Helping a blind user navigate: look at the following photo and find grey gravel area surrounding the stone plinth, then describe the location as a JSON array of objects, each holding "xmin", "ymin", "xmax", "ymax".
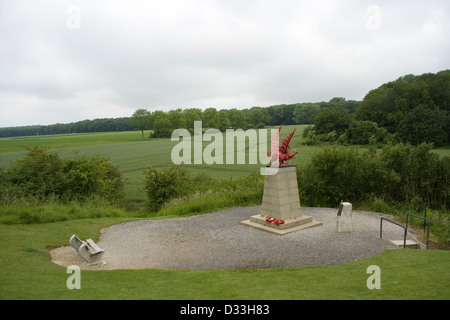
[{"xmin": 50, "ymin": 206, "xmax": 403, "ymax": 270}]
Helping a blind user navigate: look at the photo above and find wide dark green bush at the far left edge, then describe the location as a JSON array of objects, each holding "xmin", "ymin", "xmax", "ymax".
[{"xmin": 0, "ymin": 146, "xmax": 124, "ymax": 201}]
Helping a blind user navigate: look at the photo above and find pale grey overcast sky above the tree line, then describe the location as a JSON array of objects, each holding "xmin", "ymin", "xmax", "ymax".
[{"xmin": 0, "ymin": 0, "xmax": 450, "ymax": 127}]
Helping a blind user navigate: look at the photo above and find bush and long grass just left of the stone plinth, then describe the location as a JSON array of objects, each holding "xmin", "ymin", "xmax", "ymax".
[{"xmin": 145, "ymin": 165, "xmax": 264, "ymax": 215}]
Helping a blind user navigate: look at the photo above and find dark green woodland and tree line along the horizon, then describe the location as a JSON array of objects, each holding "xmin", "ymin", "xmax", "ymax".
[{"xmin": 0, "ymin": 70, "xmax": 450, "ymax": 146}]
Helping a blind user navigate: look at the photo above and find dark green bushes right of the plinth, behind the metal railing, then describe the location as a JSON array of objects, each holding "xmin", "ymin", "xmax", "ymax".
[{"xmin": 297, "ymin": 144, "xmax": 450, "ymax": 210}]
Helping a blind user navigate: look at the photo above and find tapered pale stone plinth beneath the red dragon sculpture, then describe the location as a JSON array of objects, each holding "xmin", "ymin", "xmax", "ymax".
[{"xmin": 241, "ymin": 166, "xmax": 322, "ymax": 234}]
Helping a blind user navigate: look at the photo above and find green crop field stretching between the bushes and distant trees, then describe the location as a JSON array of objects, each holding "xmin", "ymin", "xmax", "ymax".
[{"xmin": 0, "ymin": 125, "xmax": 320, "ymax": 200}]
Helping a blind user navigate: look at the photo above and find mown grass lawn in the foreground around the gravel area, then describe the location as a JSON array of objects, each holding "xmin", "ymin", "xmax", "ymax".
[{"xmin": 0, "ymin": 218, "xmax": 450, "ymax": 300}]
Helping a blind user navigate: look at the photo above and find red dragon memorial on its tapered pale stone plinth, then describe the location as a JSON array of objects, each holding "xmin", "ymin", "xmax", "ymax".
[{"xmin": 241, "ymin": 125, "xmax": 322, "ymax": 235}]
